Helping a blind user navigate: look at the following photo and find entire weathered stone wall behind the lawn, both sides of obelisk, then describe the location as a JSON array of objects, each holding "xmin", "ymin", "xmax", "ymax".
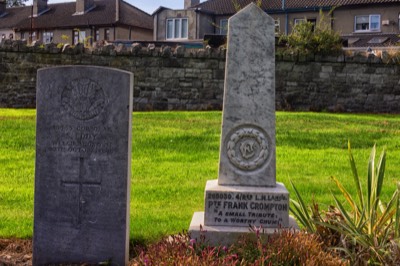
[{"xmin": 0, "ymin": 42, "xmax": 400, "ymax": 113}]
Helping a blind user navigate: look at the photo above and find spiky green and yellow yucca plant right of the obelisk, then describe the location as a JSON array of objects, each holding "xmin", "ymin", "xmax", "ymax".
[{"xmin": 292, "ymin": 142, "xmax": 400, "ymax": 264}]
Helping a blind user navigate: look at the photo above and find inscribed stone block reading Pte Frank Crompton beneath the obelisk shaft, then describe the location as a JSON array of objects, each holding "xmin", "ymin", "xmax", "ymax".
[{"xmin": 204, "ymin": 180, "xmax": 289, "ymax": 228}]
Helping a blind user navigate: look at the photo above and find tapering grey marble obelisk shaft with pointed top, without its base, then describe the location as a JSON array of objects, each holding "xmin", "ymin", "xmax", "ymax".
[{"xmin": 218, "ymin": 4, "xmax": 276, "ymax": 186}]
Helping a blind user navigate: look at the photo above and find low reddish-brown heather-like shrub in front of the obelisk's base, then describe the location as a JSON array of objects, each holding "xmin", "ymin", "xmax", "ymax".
[{"xmin": 131, "ymin": 231, "xmax": 348, "ymax": 266}]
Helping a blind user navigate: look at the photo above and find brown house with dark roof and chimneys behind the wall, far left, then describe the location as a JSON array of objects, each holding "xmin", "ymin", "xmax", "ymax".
[{"xmin": 0, "ymin": 0, "xmax": 153, "ymax": 44}]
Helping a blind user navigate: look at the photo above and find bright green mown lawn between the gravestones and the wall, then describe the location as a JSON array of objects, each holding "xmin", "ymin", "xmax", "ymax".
[{"xmin": 0, "ymin": 109, "xmax": 400, "ymax": 243}]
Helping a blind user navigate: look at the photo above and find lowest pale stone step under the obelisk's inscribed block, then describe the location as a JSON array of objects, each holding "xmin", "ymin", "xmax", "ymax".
[{"xmin": 189, "ymin": 212, "xmax": 300, "ymax": 246}]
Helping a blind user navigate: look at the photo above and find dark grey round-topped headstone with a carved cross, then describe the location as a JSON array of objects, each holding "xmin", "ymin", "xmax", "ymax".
[{"xmin": 33, "ymin": 66, "xmax": 133, "ymax": 265}]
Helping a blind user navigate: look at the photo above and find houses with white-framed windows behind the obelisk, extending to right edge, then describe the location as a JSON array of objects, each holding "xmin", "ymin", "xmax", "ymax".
[{"xmin": 153, "ymin": 0, "xmax": 400, "ymax": 46}]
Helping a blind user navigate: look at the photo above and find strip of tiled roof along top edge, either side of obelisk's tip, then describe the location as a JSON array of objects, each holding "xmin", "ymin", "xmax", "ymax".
[{"xmin": 192, "ymin": 0, "xmax": 400, "ymax": 15}]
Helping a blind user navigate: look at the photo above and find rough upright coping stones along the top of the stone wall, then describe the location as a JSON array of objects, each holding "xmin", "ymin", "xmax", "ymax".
[{"xmin": 0, "ymin": 40, "xmax": 400, "ymax": 64}]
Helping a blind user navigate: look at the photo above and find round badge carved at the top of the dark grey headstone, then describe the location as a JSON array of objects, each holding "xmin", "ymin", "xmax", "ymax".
[{"xmin": 61, "ymin": 78, "xmax": 105, "ymax": 120}]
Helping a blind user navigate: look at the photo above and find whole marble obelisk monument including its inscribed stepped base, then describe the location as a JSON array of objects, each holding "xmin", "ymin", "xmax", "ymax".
[{"xmin": 189, "ymin": 3, "xmax": 296, "ymax": 244}]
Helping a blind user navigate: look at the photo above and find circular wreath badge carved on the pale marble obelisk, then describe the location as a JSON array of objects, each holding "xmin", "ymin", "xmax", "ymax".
[{"xmin": 226, "ymin": 125, "xmax": 271, "ymax": 171}]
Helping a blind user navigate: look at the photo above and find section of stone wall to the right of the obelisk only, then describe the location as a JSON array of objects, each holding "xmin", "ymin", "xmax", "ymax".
[{"xmin": 276, "ymin": 54, "xmax": 400, "ymax": 113}]
